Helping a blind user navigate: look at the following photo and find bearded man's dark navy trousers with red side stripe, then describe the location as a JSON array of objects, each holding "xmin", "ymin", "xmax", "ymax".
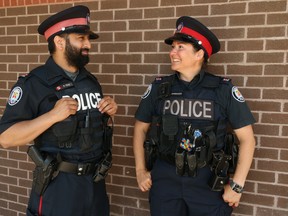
[{"xmin": 27, "ymin": 172, "xmax": 110, "ymax": 216}]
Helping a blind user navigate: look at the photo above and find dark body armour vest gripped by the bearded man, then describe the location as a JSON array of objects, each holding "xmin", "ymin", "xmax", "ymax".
[{"xmin": 30, "ymin": 66, "xmax": 103, "ymax": 160}]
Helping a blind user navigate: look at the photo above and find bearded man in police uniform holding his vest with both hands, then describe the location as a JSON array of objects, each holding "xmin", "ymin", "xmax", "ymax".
[{"xmin": 0, "ymin": 6, "xmax": 117, "ymax": 216}]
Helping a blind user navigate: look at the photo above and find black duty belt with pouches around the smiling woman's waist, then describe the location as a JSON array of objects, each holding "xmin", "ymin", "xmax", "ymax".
[{"xmin": 144, "ymin": 137, "xmax": 238, "ymax": 191}]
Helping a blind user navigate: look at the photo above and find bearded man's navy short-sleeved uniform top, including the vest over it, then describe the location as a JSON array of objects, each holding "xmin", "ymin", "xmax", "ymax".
[{"xmin": 0, "ymin": 57, "xmax": 103, "ymax": 161}]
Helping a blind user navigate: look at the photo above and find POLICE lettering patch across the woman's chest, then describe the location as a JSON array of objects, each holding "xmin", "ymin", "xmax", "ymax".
[{"xmin": 163, "ymin": 99, "xmax": 214, "ymax": 120}]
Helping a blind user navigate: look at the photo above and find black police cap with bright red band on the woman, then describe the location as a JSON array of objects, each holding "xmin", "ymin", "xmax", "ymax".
[{"xmin": 165, "ymin": 16, "xmax": 220, "ymax": 58}]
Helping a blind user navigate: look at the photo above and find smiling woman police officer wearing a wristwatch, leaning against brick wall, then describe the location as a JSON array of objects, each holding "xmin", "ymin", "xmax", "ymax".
[{"xmin": 133, "ymin": 16, "xmax": 255, "ymax": 216}]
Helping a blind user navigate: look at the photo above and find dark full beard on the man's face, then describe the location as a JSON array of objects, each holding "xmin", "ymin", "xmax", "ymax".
[{"xmin": 65, "ymin": 39, "xmax": 89, "ymax": 68}]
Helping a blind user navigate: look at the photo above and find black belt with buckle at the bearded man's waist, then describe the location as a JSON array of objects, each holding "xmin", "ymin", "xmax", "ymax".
[{"xmin": 57, "ymin": 161, "xmax": 98, "ymax": 176}]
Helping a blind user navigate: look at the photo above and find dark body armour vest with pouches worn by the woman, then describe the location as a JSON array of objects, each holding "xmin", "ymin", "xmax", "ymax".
[{"xmin": 150, "ymin": 72, "xmax": 227, "ymax": 167}]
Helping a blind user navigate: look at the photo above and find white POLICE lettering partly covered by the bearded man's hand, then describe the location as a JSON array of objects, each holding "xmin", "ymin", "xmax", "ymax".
[{"xmin": 63, "ymin": 93, "xmax": 102, "ymax": 111}]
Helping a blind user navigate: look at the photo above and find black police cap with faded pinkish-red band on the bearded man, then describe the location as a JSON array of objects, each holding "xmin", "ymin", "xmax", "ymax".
[{"xmin": 38, "ymin": 5, "xmax": 99, "ymax": 41}]
